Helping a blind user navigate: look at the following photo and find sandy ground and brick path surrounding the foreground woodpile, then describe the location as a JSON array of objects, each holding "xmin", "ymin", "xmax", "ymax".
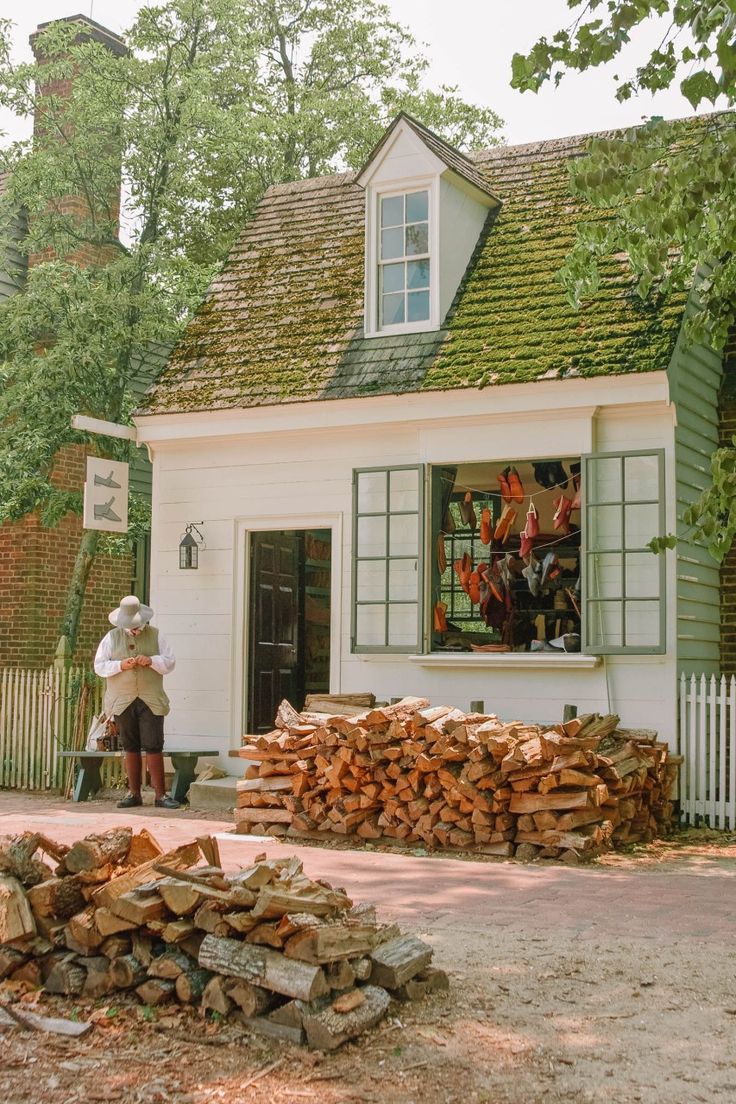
[{"xmin": 0, "ymin": 794, "xmax": 736, "ymax": 1104}]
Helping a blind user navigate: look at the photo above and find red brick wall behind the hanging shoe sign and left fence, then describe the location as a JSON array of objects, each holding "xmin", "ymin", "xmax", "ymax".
[{"xmin": 0, "ymin": 446, "xmax": 132, "ymax": 667}]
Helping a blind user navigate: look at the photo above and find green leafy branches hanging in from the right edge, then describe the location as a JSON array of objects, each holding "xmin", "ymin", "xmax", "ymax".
[{"xmin": 512, "ymin": 0, "xmax": 736, "ymax": 562}]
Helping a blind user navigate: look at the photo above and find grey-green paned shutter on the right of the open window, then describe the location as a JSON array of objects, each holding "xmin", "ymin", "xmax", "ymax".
[{"xmin": 582, "ymin": 449, "xmax": 665, "ymax": 656}]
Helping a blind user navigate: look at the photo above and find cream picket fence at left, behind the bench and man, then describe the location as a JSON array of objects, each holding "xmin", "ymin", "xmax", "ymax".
[{"xmin": 0, "ymin": 667, "xmax": 106, "ymax": 789}]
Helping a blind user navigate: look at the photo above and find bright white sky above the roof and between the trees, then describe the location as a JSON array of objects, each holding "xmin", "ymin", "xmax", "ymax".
[{"xmin": 0, "ymin": 0, "xmax": 693, "ymax": 144}]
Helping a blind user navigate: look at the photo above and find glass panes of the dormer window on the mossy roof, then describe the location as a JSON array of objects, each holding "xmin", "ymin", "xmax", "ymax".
[{"xmin": 378, "ymin": 189, "xmax": 430, "ymax": 329}]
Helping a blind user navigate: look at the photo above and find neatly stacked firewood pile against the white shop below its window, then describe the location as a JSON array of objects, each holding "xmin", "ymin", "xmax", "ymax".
[{"xmin": 235, "ymin": 698, "xmax": 676, "ymax": 861}]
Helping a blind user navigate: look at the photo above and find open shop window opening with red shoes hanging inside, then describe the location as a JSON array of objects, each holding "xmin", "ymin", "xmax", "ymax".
[{"xmin": 431, "ymin": 457, "xmax": 583, "ymax": 654}]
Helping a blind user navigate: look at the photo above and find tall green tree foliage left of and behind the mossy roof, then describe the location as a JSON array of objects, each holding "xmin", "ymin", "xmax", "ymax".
[{"xmin": 0, "ymin": 0, "xmax": 500, "ymax": 647}]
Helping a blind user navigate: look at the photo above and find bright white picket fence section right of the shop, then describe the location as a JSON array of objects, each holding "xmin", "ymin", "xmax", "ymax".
[{"xmin": 678, "ymin": 675, "xmax": 736, "ymax": 831}]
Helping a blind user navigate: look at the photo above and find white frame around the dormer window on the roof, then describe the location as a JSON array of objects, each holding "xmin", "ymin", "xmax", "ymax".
[{"xmin": 364, "ymin": 177, "xmax": 440, "ymax": 338}]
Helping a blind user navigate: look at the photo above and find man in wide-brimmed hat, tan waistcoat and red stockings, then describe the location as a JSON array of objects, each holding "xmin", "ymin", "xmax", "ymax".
[{"xmin": 95, "ymin": 594, "xmax": 179, "ymax": 809}]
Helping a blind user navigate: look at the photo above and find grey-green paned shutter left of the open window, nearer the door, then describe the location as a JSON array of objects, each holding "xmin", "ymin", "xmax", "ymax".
[{"xmin": 351, "ymin": 465, "xmax": 425, "ymax": 652}]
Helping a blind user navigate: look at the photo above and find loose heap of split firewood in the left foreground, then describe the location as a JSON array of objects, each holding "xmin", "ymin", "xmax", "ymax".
[{"xmin": 0, "ymin": 828, "xmax": 447, "ymax": 1050}]
